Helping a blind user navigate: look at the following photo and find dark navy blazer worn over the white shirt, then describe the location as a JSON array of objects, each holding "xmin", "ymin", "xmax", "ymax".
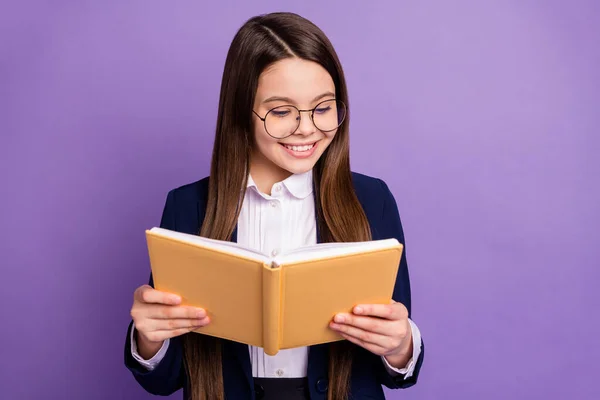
[{"xmin": 125, "ymin": 173, "xmax": 425, "ymax": 400}]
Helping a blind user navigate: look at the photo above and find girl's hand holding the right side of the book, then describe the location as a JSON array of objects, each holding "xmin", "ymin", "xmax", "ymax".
[{"xmin": 329, "ymin": 300, "xmax": 413, "ymax": 368}]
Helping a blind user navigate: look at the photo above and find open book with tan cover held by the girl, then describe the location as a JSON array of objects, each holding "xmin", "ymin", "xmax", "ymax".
[{"xmin": 146, "ymin": 228, "xmax": 403, "ymax": 355}]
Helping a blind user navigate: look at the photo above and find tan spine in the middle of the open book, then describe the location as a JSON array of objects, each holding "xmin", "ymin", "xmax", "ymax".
[{"xmin": 262, "ymin": 265, "xmax": 281, "ymax": 356}]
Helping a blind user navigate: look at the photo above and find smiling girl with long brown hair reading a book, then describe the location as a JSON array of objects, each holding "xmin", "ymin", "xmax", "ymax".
[{"xmin": 125, "ymin": 13, "xmax": 424, "ymax": 400}]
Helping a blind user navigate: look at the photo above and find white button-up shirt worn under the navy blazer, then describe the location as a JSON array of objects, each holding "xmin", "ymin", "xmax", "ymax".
[{"xmin": 130, "ymin": 171, "xmax": 421, "ymax": 379}]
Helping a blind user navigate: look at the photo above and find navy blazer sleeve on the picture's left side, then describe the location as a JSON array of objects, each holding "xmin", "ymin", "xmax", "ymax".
[{"xmin": 124, "ymin": 191, "xmax": 185, "ymax": 396}]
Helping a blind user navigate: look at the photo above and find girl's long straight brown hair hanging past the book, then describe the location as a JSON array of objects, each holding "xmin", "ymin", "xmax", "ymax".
[{"xmin": 184, "ymin": 13, "xmax": 371, "ymax": 400}]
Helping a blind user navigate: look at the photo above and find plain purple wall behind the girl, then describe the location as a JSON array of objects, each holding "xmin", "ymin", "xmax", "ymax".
[{"xmin": 0, "ymin": 0, "xmax": 600, "ymax": 400}]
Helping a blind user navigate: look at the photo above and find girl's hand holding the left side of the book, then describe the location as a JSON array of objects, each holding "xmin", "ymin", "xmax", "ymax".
[{"xmin": 131, "ymin": 285, "xmax": 210, "ymax": 359}]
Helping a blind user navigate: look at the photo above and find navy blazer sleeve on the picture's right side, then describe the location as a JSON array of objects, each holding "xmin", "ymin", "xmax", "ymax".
[{"xmin": 374, "ymin": 180, "xmax": 425, "ymax": 389}]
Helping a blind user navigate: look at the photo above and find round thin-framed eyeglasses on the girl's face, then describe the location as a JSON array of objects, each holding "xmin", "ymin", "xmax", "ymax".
[{"xmin": 252, "ymin": 99, "xmax": 346, "ymax": 139}]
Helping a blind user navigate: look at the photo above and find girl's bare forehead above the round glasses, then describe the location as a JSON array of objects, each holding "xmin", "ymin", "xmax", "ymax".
[{"xmin": 256, "ymin": 58, "xmax": 335, "ymax": 103}]
